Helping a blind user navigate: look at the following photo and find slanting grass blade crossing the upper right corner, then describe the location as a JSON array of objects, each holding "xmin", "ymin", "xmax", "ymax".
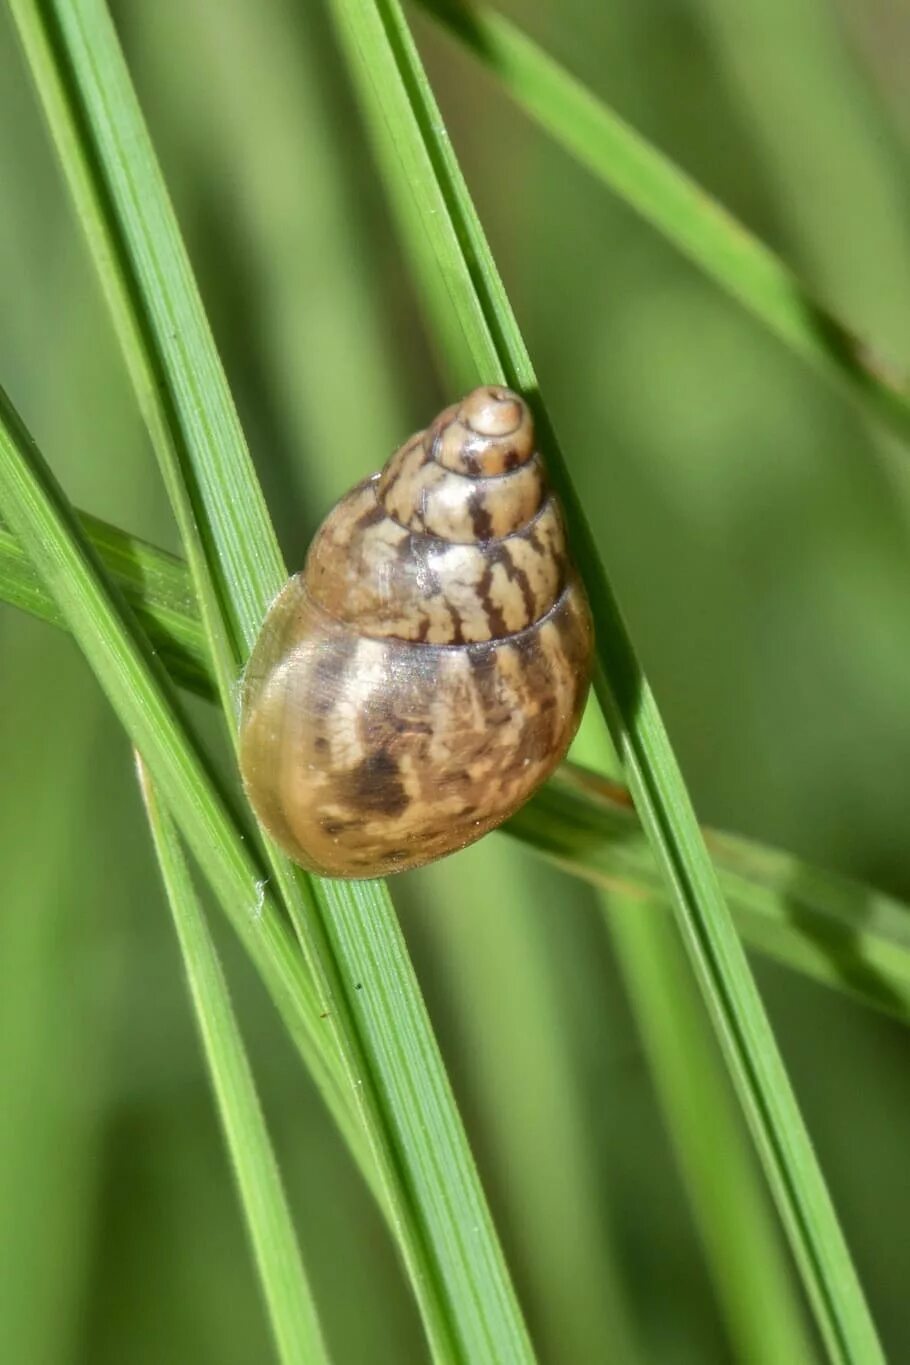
[{"xmin": 419, "ymin": 0, "xmax": 910, "ymax": 442}]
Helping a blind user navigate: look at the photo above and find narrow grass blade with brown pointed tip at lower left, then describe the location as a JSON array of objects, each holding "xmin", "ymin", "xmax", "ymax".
[{"xmin": 136, "ymin": 756, "xmax": 329, "ymax": 1365}]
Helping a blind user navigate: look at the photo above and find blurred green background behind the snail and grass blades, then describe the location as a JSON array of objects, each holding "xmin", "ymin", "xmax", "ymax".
[{"xmin": 0, "ymin": 0, "xmax": 910, "ymax": 1365}]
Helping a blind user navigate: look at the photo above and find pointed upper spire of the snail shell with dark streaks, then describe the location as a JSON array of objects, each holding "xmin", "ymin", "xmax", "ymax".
[{"xmin": 304, "ymin": 388, "xmax": 568, "ymax": 644}]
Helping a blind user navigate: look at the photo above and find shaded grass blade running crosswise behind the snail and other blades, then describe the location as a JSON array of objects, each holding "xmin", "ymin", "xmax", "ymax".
[{"xmin": 0, "ymin": 513, "xmax": 910, "ymax": 1022}]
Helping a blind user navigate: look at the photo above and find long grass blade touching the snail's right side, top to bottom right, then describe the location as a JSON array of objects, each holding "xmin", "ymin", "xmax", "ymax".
[{"xmin": 326, "ymin": 0, "xmax": 880, "ymax": 1362}]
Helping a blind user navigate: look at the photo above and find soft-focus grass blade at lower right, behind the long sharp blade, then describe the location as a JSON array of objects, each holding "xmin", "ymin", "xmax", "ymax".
[{"xmin": 572, "ymin": 713, "xmax": 814, "ymax": 1365}]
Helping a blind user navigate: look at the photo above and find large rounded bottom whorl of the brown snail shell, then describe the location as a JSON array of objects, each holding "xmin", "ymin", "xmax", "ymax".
[{"xmin": 241, "ymin": 576, "xmax": 591, "ymax": 876}]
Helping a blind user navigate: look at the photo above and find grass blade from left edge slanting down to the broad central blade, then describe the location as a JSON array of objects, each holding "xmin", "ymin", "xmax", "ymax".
[{"xmin": 0, "ymin": 390, "xmax": 372, "ymax": 1206}]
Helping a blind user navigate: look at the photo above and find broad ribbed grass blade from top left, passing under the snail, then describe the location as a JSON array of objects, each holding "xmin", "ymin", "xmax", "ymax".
[{"xmin": 14, "ymin": 0, "xmax": 529, "ymax": 1360}]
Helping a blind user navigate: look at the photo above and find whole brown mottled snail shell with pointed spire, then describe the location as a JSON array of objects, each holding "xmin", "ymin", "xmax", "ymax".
[{"xmin": 240, "ymin": 386, "xmax": 592, "ymax": 878}]
